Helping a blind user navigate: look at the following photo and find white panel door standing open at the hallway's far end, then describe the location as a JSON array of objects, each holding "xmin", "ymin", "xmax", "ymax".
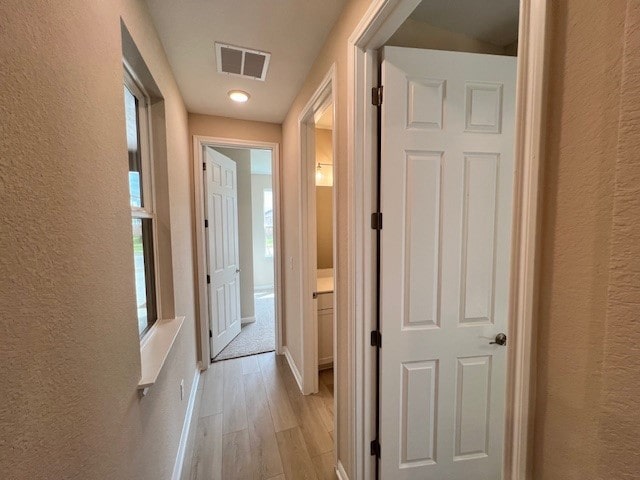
[{"xmin": 204, "ymin": 148, "xmax": 241, "ymax": 357}]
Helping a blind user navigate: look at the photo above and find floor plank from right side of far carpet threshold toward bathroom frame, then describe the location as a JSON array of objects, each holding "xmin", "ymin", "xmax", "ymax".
[{"xmin": 258, "ymin": 353, "xmax": 298, "ymax": 432}]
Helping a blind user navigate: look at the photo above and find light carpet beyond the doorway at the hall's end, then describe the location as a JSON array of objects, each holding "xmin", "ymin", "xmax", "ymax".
[{"xmin": 213, "ymin": 290, "xmax": 276, "ymax": 362}]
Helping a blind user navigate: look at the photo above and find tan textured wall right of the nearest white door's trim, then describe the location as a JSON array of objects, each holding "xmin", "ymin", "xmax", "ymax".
[{"xmin": 533, "ymin": 0, "xmax": 640, "ymax": 480}]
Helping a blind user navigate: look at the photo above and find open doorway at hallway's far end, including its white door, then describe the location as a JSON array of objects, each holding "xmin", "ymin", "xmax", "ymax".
[{"xmin": 194, "ymin": 137, "xmax": 281, "ymax": 362}]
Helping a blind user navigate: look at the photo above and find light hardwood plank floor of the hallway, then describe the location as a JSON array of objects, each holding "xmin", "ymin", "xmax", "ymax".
[{"xmin": 182, "ymin": 352, "xmax": 337, "ymax": 480}]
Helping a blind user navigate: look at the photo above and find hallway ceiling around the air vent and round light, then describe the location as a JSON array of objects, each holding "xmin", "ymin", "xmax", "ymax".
[{"xmin": 146, "ymin": 0, "xmax": 346, "ymax": 123}]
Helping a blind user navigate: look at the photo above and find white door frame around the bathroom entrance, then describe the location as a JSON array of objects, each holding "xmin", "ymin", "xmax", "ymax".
[{"xmin": 300, "ymin": 63, "xmax": 339, "ymax": 396}]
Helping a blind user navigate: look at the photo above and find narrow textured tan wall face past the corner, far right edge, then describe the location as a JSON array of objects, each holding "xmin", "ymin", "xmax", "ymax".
[{"xmin": 598, "ymin": 1, "xmax": 640, "ymax": 479}]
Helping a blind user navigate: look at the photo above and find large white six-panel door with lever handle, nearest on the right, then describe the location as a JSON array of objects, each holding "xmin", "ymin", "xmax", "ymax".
[{"xmin": 380, "ymin": 47, "xmax": 516, "ymax": 480}]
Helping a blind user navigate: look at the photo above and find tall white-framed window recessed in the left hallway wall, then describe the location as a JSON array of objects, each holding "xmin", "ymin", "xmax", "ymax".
[{"xmin": 124, "ymin": 68, "xmax": 158, "ymax": 337}]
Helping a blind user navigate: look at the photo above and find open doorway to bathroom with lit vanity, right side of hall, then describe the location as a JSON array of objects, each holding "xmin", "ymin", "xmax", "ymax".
[{"xmin": 299, "ymin": 66, "xmax": 339, "ymax": 396}]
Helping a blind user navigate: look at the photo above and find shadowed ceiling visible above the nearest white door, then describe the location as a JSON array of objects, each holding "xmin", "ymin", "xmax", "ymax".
[{"xmin": 411, "ymin": 0, "xmax": 520, "ymax": 47}]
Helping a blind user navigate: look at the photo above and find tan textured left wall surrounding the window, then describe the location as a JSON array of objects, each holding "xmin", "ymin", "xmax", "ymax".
[{"xmin": 0, "ymin": 0, "xmax": 196, "ymax": 480}]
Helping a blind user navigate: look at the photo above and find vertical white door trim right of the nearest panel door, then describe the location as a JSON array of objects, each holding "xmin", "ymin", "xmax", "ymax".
[{"xmin": 503, "ymin": 0, "xmax": 548, "ymax": 480}]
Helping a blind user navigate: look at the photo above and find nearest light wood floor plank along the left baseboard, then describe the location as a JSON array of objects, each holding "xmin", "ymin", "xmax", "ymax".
[{"xmin": 188, "ymin": 414, "xmax": 223, "ymax": 480}]
